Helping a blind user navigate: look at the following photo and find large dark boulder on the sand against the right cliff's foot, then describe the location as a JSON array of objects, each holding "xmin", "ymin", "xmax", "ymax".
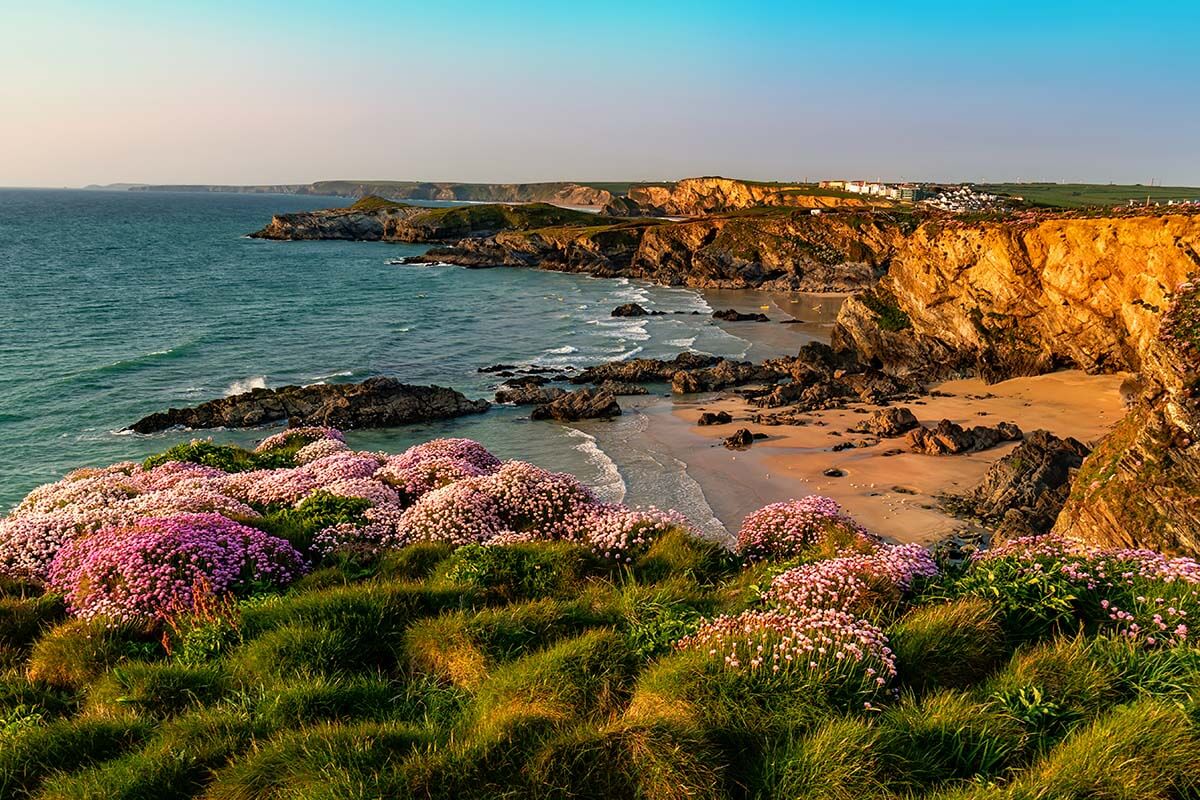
[{"xmin": 943, "ymin": 431, "xmax": 1088, "ymax": 536}]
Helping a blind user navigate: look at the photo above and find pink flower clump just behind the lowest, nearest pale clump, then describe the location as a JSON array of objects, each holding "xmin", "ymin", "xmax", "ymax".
[{"xmin": 766, "ymin": 545, "xmax": 937, "ymax": 615}]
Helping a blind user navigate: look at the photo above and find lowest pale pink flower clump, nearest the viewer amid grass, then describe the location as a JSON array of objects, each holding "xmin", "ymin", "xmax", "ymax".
[{"xmin": 677, "ymin": 609, "xmax": 896, "ymax": 702}]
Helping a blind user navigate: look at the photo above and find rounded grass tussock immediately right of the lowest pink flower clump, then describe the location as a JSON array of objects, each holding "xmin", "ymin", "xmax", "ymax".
[{"xmin": 888, "ymin": 597, "xmax": 1008, "ymax": 690}]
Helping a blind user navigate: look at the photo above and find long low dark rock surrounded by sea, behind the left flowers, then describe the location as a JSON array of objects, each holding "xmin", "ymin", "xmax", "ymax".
[{"xmin": 130, "ymin": 378, "xmax": 491, "ymax": 433}]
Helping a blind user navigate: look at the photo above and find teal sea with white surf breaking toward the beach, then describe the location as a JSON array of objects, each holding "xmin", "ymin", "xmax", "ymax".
[{"xmin": 0, "ymin": 190, "xmax": 763, "ymax": 518}]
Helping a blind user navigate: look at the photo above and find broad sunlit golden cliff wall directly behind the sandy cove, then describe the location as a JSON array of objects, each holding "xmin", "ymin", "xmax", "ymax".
[{"xmin": 835, "ymin": 215, "xmax": 1200, "ymax": 380}]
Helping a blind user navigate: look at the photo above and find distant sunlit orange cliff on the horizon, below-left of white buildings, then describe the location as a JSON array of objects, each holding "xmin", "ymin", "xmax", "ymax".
[{"xmin": 626, "ymin": 178, "xmax": 890, "ymax": 217}]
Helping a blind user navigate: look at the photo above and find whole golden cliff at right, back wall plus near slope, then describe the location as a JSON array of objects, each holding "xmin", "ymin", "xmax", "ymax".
[{"xmin": 835, "ymin": 215, "xmax": 1200, "ymax": 554}]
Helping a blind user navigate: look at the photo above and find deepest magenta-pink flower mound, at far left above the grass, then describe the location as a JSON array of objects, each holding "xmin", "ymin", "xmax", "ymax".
[{"xmin": 49, "ymin": 513, "xmax": 305, "ymax": 622}]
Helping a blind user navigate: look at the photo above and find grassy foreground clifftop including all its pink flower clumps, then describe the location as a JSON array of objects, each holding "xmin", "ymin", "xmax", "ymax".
[{"xmin": 7, "ymin": 429, "xmax": 1200, "ymax": 800}]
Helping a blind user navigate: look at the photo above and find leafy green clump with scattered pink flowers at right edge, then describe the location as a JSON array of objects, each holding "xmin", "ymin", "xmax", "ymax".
[{"xmin": 964, "ymin": 534, "xmax": 1200, "ymax": 645}]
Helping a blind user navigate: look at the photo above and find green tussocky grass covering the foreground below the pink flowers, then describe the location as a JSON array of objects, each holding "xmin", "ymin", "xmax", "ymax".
[{"xmin": 0, "ymin": 533, "xmax": 1200, "ymax": 800}]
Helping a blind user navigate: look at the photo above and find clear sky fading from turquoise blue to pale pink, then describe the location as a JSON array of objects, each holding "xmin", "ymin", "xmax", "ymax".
[{"xmin": 0, "ymin": 0, "xmax": 1200, "ymax": 186}]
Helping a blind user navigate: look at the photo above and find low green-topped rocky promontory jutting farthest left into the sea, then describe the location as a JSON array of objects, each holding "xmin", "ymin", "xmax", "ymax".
[{"xmin": 251, "ymin": 197, "xmax": 604, "ymax": 242}]
